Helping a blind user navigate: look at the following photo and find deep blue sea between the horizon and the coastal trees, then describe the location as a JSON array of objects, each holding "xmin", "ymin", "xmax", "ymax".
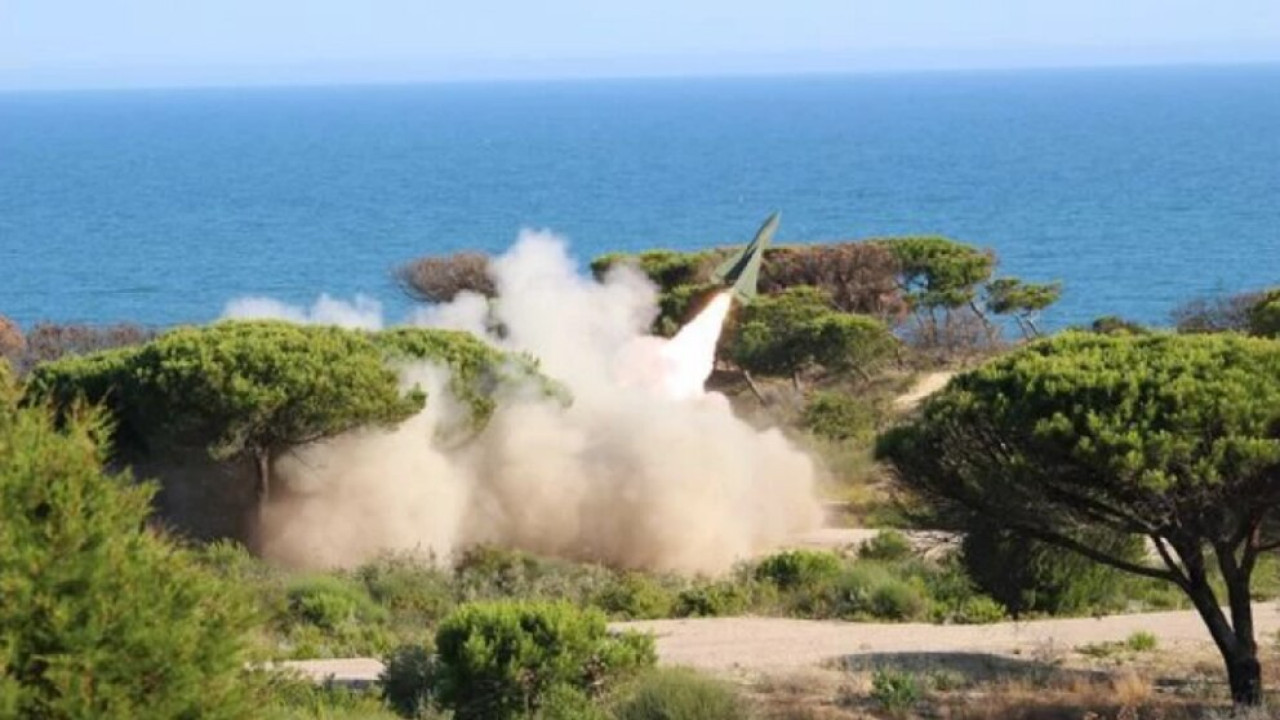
[{"xmin": 0, "ymin": 67, "xmax": 1280, "ymax": 325}]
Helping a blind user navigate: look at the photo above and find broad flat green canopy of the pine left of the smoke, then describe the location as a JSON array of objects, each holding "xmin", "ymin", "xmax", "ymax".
[{"xmin": 29, "ymin": 322, "xmax": 424, "ymax": 471}]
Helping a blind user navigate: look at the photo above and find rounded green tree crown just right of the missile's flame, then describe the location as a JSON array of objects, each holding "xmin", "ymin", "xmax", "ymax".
[{"xmin": 728, "ymin": 287, "xmax": 897, "ymax": 375}]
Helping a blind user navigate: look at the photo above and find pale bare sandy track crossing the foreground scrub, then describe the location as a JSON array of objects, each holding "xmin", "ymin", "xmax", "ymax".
[{"xmin": 280, "ymin": 602, "xmax": 1280, "ymax": 684}]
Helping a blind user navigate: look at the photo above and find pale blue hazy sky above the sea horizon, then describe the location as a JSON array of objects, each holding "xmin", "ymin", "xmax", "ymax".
[{"xmin": 0, "ymin": 0, "xmax": 1280, "ymax": 90}]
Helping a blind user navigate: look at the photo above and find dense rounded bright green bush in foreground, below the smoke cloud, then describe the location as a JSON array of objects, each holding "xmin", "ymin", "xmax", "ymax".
[{"xmin": 435, "ymin": 602, "xmax": 657, "ymax": 720}]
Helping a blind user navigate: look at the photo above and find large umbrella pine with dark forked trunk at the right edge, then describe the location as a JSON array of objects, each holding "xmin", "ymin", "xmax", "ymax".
[{"xmin": 879, "ymin": 333, "xmax": 1280, "ymax": 703}]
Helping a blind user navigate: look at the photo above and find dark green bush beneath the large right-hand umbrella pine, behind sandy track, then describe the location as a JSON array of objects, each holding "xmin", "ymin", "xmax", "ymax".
[{"xmin": 960, "ymin": 521, "xmax": 1143, "ymax": 618}]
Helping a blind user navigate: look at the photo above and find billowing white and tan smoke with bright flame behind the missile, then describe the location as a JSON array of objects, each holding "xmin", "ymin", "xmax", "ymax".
[{"xmin": 229, "ymin": 232, "xmax": 820, "ymax": 573}]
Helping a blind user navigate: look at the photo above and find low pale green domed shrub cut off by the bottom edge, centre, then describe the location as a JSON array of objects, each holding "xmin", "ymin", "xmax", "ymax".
[{"xmin": 613, "ymin": 669, "xmax": 748, "ymax": 720}]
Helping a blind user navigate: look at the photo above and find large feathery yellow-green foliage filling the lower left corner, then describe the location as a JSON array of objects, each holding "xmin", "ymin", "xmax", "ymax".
[{"xmin": 0, "ymin": 402, "xmax": 252, "ymax": 719}]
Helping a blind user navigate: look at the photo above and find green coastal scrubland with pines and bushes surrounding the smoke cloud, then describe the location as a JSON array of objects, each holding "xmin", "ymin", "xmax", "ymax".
[{"xmin": 0, "ymin": 237, "xmax": 1280, "ymax": 720}]
